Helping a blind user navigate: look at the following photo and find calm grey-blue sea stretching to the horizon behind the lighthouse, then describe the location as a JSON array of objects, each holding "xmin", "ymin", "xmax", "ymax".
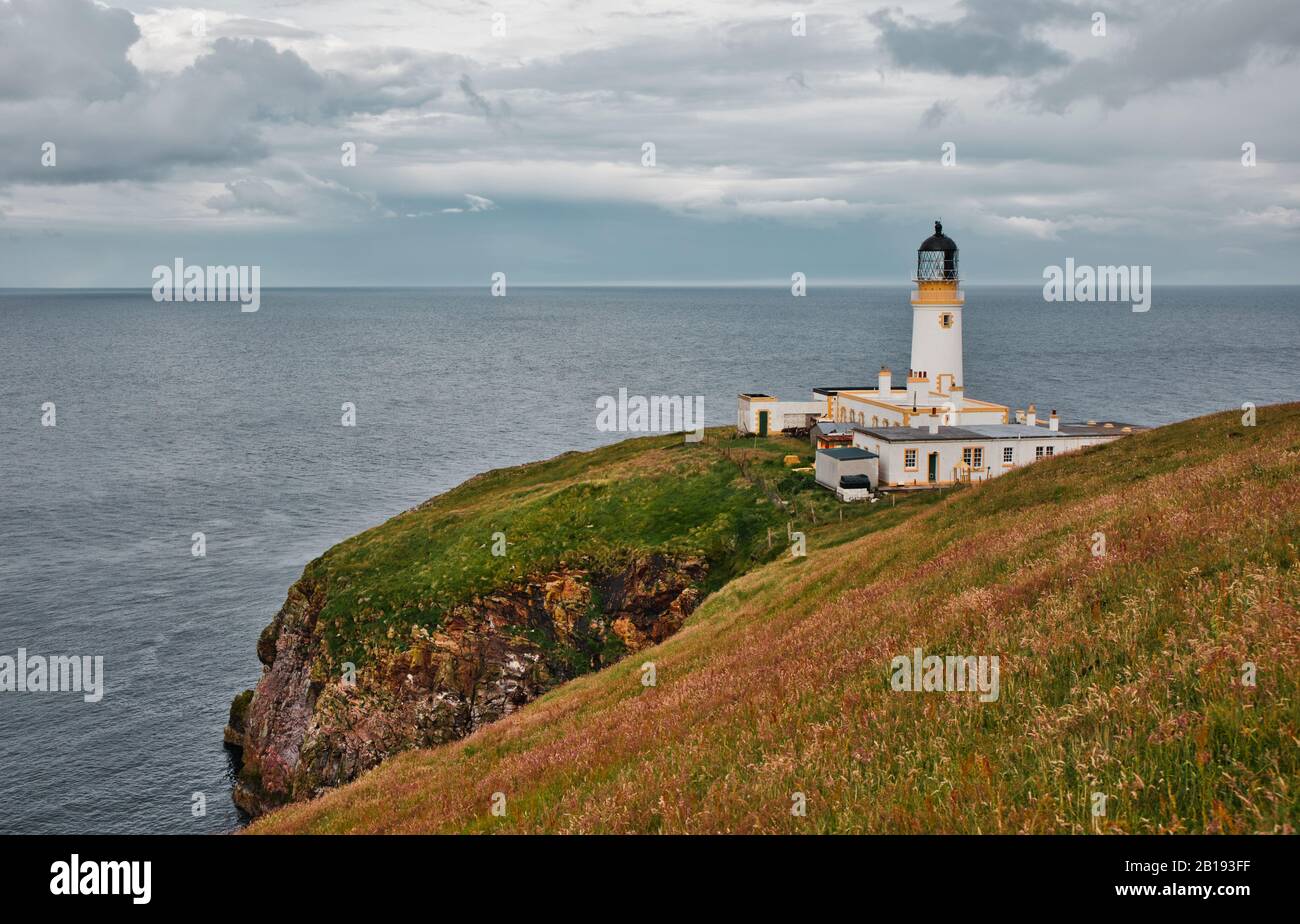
[{"xmin": 0, "ymin": 286, "xmax": 1300, "ymax": 833}]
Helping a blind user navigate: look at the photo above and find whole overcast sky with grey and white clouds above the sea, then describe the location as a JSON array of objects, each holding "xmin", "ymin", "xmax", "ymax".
[{"xmin": 0, "ymin": 0, "xmax": 1300, "ymax": 287}]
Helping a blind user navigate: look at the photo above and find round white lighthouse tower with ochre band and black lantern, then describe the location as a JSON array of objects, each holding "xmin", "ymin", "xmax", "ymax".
[{"xmin": 907, "ymin": 221, "xmax": 965, "ymax": 395}]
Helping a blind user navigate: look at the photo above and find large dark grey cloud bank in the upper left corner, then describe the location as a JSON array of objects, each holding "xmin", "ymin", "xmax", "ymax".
[{"xmin": 0, "ymin": 0, "xmax": 441, "ymax": 186}]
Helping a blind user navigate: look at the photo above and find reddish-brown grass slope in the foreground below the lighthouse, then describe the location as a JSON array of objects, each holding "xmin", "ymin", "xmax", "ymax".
[{"xmin": 251, "ymin": 404, "xmax": 1300, "ymax": 833}]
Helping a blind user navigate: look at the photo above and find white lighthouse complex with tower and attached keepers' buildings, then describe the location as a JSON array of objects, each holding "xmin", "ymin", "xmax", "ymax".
[{"xmin": 736, "ymin": 221, "xmax": 1141, "ymax": 499}]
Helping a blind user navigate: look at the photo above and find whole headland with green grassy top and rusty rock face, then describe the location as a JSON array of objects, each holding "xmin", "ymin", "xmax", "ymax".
[{"xmin": 233, "ymin": 431, "xmax": 930, "ymax": 815}]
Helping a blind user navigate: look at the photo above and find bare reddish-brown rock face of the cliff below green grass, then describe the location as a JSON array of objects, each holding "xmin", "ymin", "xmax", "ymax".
[{"xmin": 226, "ymin": 554, "xmax": 707, "ymax": 816}]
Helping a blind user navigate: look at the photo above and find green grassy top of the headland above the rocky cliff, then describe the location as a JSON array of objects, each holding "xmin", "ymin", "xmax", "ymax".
[{"xmin": 304, "ymin": 428, "xmax": 922, "ymax": 664}]
